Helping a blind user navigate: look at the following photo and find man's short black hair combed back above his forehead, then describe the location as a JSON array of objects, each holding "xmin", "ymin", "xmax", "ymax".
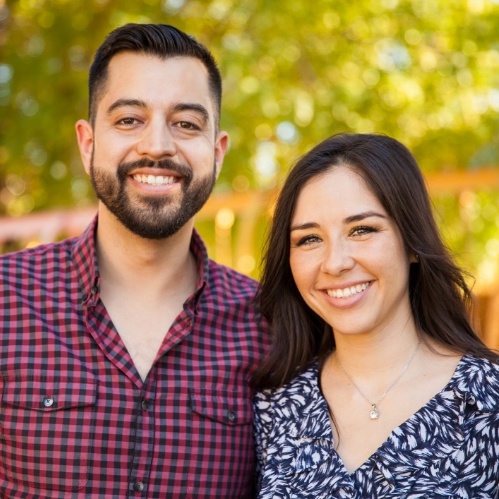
[{"xmin": 88, "ymin": 24, "xmax": 222, "ymax": 124}]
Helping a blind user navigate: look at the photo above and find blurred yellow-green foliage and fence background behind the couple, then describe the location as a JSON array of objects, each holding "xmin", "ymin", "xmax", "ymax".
[{"xmin": 0, "ymin": 0, "xmax": 499, "ymax": 347}]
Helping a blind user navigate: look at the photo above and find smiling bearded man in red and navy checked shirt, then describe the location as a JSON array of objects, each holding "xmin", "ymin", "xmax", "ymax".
[{"xmin": 0, "ymin": 25, "xmax": 267, "ymax": 498}]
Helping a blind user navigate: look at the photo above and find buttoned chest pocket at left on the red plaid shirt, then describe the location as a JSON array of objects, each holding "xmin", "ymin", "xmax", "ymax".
[{"xmin": 0, "ymin": 372, "xmax": 97, "ymax": 491}]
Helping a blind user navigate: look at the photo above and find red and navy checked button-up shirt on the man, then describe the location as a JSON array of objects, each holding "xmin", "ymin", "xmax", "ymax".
[{"xmin": 0, "ymin": 220, "xmax": 267, "ymax": 499}]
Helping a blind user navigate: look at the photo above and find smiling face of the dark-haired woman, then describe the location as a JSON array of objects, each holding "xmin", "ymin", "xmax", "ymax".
[{"xmin": 290, "ymin": 166, "xmax": 411, "ymax": 337}]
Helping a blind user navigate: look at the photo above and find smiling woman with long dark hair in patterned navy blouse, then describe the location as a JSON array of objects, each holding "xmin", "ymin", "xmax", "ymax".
[{"xmin": 255, "ymin": 134, "xmax": 499, "ymax": 499}]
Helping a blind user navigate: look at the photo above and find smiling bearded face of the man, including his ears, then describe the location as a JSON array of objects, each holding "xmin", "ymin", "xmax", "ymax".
[{"xmin": 77, "ymin": 52, "xmax": 227, "ymax": 239}]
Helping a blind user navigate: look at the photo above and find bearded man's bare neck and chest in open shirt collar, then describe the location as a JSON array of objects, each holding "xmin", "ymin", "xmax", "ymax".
[{"xmin": 93, "ymin": 209, "xmax": 198, "ymax": 379}]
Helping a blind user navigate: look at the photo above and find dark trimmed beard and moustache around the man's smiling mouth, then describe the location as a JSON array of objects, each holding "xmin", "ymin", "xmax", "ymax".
[{"xmin": 90, "ymin": 157, "xmax": 216, "ymax": 239}]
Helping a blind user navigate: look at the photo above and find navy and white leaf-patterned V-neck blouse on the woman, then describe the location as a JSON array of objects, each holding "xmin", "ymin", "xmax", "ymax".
[{"xmin": 255, "ymin": 356, "xmax": 499, "ymax": 499}]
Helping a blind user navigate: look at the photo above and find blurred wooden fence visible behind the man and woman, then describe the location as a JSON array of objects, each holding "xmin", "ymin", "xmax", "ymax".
[{"xmin": 0, "ymin": 167, "xmax": 499, "ymax": 349}]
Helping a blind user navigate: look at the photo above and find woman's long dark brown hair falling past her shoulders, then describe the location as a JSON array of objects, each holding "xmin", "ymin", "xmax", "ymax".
[{"xmin": 253, "ymin": 134, "xmax": 498, "ymax": 389}]
